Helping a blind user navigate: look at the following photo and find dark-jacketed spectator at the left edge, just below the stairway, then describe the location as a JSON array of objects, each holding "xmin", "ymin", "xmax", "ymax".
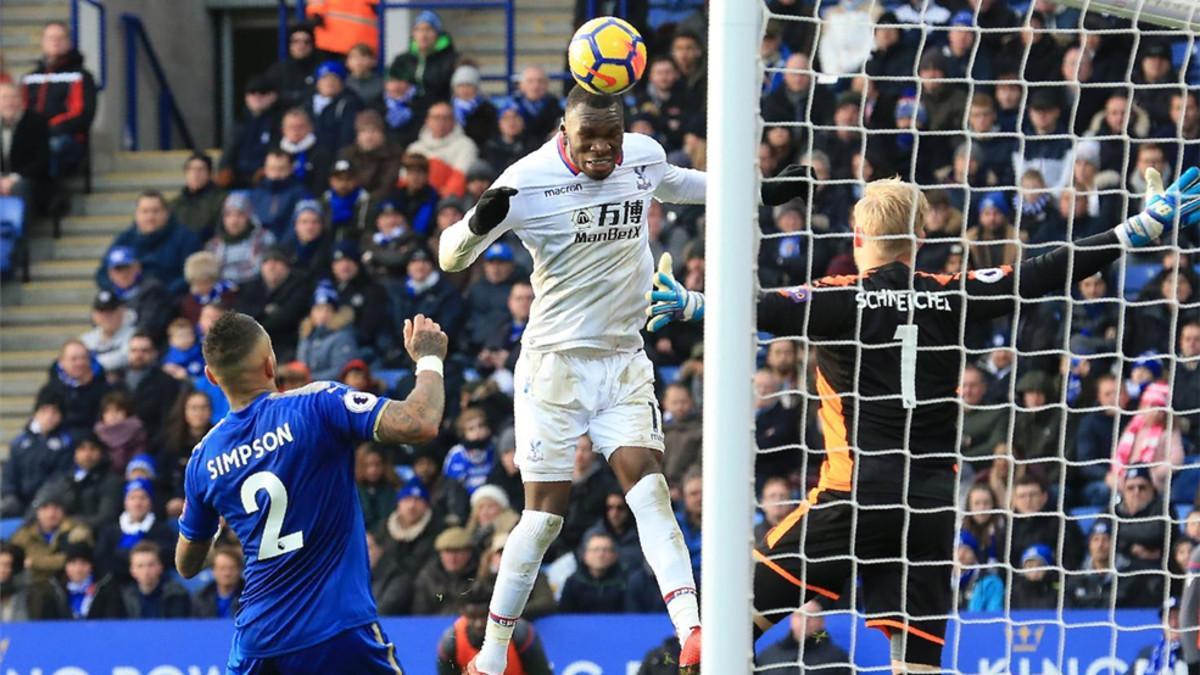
[{"xmin": 0, "ymin": 390, "xmax": 72, "ymax": 518}]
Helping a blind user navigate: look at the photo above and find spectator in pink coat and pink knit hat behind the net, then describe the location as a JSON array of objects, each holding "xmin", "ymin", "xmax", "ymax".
[{"xmin": 1109, "ymin": 382, "xmax": 1183, "ymax": 491}]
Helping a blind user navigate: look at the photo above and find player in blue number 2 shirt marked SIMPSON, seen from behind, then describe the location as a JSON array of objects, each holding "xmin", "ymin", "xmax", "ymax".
[{"xmin": 175, "ymin": 312, "xmax": 446, "ymax": 675}]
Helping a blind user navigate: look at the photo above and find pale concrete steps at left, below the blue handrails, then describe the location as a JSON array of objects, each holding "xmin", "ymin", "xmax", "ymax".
[{"xmin": 0, "ymin": 148, "xmax": 194, "ymax": 452}]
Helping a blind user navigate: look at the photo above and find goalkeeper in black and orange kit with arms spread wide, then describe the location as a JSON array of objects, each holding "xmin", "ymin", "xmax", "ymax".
[{"xmin": 647, "ymin": 168, "xmax": 1200, "ymax": 673}]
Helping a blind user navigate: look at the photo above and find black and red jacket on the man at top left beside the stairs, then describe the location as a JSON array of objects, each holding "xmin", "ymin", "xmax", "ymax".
[{"xmin": 20, "ymin": 49, "xmax": 96, "ymax": 141}]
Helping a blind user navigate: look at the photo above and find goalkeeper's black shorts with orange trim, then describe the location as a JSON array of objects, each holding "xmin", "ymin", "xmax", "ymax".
[{"xmin": 754, "ymin": 490, "xmax": 954, "ymax": 665}]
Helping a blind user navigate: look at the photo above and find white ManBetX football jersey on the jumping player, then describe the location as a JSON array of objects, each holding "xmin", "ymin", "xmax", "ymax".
[{"xmin": 439, "ymin": 133, "xmax": 704, "ymax": 352}]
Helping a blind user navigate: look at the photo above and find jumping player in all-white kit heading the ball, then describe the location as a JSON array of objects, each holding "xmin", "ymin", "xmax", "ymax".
[{"xmin": 439, "ymin": 86, "xmax": 803, "ymax": 675}]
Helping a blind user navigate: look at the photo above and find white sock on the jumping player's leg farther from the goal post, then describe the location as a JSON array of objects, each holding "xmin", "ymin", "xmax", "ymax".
[{"xmin": 475, "ymin": 510, "xmax": 563, "ymax": 675}]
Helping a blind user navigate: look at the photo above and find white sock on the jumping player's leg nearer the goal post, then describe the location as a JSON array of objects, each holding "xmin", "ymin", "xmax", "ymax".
[{"xmin": 628, "ymin": 473, "xmax": 700, "ymax": 645}]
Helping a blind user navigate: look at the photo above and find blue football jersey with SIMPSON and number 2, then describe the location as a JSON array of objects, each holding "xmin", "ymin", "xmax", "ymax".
[{"xmin": 179, "ymin": 382, "xmax": 386, "ymax": 657}]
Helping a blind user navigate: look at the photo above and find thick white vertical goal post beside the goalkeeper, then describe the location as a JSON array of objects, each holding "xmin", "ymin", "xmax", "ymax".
[{"xmin": 701, "ymin": 0, "xmax": 763, "ymax": 674}]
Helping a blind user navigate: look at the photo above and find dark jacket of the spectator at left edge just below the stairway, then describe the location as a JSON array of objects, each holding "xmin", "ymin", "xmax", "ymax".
[{"xmin": 0, "ymin": 425, "xmax": 74, "ymax": 518}]
